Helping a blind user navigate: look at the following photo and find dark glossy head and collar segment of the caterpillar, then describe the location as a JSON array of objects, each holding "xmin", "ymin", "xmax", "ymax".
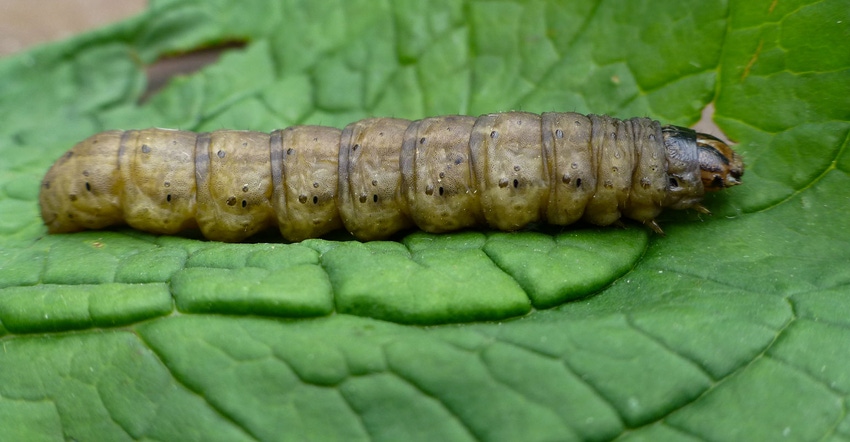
[{"xmin": 661, "ymin": 126, "xmax": 744, "ymax": 211}]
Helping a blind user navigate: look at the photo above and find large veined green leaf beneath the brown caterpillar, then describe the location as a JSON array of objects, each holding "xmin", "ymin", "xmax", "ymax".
[{"xmin": 0, "ymin": 0, "xmax": 850, "ymax": 441}]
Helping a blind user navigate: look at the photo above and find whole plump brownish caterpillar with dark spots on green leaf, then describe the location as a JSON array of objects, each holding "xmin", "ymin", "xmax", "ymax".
[{"xmin": 39, "ymin": 112, "xmax": 744, "ymax": 242}]
